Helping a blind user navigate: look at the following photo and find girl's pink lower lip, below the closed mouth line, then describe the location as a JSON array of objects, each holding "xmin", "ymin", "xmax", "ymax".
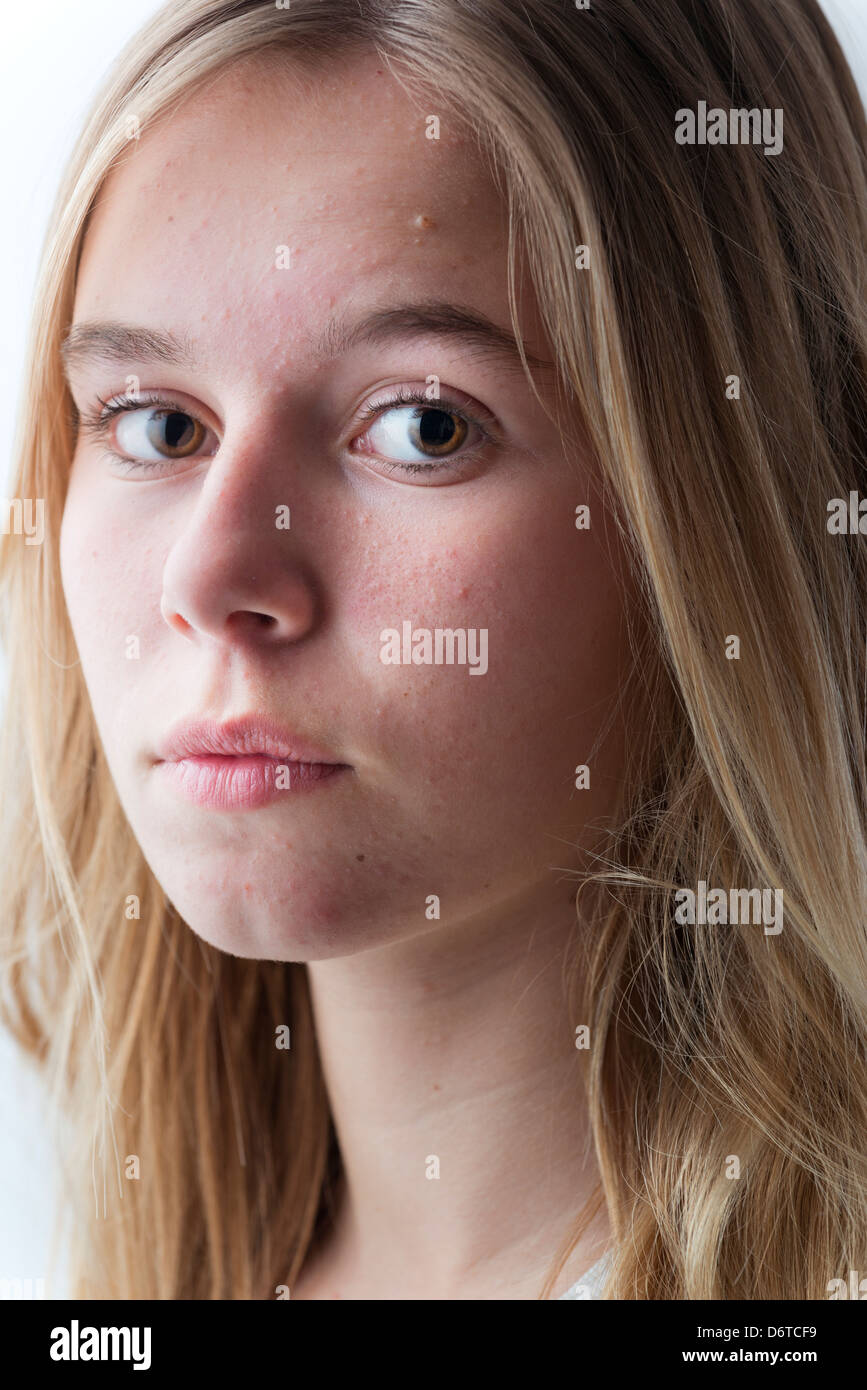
[{"xmin": 157, "ymin": 753, "xmax": 349, "ymax": 810}]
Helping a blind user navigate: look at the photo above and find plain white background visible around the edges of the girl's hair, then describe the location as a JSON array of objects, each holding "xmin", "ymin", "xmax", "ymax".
[{"xmin": 0, "ymin": 0, "xmax": 867, "ymax": 1297}]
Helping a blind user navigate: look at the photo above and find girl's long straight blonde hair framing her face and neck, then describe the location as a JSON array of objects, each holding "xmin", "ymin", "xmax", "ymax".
[{"xmin": 0, "ymin": 0, "xmax": 867, "ymax": 1298}]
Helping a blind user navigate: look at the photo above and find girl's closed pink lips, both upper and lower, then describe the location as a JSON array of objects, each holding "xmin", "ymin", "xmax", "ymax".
[{"xmin": 156, "ymin": 717, "xmax": 349, "ymax": 810}]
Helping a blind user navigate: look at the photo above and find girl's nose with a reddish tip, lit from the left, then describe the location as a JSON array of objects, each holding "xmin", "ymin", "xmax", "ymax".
[{"xmin": 160, "ymin": 430, "xmax": 317, "ymax": 645}]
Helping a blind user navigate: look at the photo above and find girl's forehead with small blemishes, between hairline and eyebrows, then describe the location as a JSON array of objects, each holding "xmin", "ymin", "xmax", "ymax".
[{"xmin": 75, "ymin": 53, "xmax": 509, "ymax": 386}]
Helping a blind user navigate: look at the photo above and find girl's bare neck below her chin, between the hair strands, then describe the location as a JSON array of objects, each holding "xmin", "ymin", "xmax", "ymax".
[{"xmin": 293, "ymin": 888, "xmax": 607, "ymax": 1300}]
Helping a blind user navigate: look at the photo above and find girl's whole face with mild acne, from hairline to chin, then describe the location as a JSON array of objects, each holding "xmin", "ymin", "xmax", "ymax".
[{"xmin": 61, "ymin": 56, "xmax": 628, "ymax": 960}]
